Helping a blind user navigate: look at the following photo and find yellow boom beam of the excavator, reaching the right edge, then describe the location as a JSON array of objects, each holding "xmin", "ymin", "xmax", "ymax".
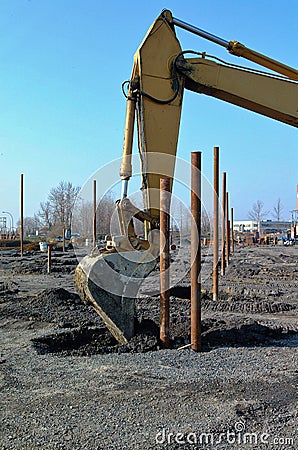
[{"xmin": 181, "ymin": 58, "xmax": 298, "ymax": 127}]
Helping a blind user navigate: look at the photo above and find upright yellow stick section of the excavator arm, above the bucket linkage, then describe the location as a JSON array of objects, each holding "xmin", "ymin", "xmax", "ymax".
[{"xmin": 134, "ymin": 16, "xmax": 183, "ymax": 216}]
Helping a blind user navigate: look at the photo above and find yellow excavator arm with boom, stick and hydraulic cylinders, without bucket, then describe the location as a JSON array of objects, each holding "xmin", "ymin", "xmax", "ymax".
[{"xmin": 120, "ymin": 10, "xmax": 298, "ymax": 227}]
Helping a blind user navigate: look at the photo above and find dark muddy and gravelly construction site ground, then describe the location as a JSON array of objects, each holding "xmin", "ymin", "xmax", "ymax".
[{"xmin": 0, "ymin": 244, "xmax": 298, "ymax": 450}]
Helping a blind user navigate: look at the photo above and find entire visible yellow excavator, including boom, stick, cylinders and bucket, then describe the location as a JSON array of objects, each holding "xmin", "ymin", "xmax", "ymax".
[{"xmin": 75, "ymin": 10, "xmax": 298, "ymax": 344}]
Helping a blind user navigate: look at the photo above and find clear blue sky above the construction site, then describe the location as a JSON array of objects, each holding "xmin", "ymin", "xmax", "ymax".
[{"xmin": 0, "ymin": 0, "xmax": 298, "ymax": 225}]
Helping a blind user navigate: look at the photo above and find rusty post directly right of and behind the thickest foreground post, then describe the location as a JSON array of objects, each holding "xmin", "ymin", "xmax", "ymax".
[{"xmin": 213, "ymin": 147, "xmax": 219, "ymax": 300}]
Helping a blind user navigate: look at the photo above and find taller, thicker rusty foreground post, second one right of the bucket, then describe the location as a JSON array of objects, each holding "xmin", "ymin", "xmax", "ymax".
[{"xmin": 190, "ymin": 152, "xmax": 202, "ymax": 352}]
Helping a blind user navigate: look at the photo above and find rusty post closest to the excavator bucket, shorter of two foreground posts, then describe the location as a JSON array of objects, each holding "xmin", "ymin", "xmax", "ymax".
[{"xmin": 160, "ymin": 178, "xmax": 171, "ymax": 348}]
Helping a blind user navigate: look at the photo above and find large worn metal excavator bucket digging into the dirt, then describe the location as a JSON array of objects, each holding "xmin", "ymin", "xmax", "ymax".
[{"xmin": 75, "ymin": 250, "xmax": 156, "ymax": 344}]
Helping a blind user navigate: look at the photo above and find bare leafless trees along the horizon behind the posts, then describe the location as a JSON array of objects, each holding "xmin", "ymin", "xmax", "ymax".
[{"xmin": 19, "ymin": 181, "xmax": 284, "ymax": 241}]
